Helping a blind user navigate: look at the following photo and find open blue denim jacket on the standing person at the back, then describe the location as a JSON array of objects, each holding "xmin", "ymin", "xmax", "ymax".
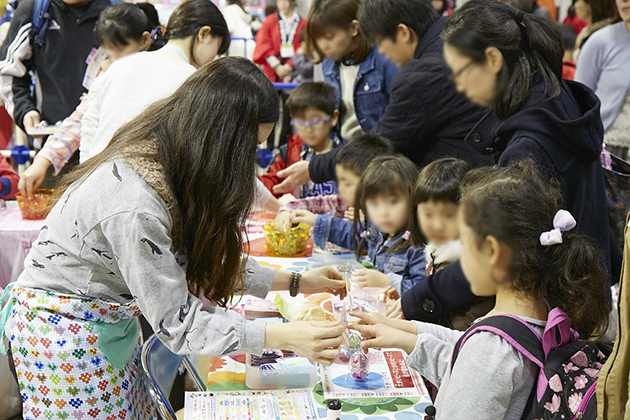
[{"xmin": 322, "ymin": 49, "xmax": 398, "ymax": 140}]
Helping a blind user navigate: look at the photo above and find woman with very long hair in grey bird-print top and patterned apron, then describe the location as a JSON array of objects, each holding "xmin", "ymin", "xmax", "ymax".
[{"xmin": 1, "ymin": 58, "xmax": 345, "ymax": 420}]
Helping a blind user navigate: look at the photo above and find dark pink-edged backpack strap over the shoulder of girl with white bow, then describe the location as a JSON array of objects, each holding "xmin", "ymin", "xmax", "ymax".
[{"xmin": 451, "ymin": 315, "xmax": 545, "ymax": 371}]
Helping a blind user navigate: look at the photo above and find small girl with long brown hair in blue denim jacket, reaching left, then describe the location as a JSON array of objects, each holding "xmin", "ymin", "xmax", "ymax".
[{"xmin": 293, "ymin": 156, "xmax": 426, "ymax": 293}]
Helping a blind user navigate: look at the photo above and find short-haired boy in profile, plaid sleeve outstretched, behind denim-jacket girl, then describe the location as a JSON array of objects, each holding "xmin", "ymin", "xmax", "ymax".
[{"xmin": 276, "ymin": 134, "xmax": 394, "ymax": 229}]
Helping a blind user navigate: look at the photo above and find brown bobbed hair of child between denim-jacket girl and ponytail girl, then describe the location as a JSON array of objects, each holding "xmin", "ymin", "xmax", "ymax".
[{"xmin": 410, "ymin": 158, "xmax": 471, "ymax": 247}]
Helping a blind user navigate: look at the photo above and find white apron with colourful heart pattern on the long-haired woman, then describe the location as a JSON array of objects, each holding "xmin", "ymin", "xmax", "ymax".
[{"xmin": 10, "ymin": 286, "xmax": 158, "ymax": 420}]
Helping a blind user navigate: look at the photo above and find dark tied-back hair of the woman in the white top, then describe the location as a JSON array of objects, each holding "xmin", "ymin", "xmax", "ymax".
[{"xmin": 166, "ymin": 0, "xmax": 231, "ymax": 63}]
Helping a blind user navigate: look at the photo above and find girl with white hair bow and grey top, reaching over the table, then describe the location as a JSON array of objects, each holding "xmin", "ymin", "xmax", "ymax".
[{"xmin": 353, "ymin": 159, "xmax": 609, "ymax": 420}]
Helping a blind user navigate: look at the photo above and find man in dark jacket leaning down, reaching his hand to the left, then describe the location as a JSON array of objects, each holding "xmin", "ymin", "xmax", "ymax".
[{"xmin": 274, "ymin": 0, "xmax": 492, "ymax": 192}]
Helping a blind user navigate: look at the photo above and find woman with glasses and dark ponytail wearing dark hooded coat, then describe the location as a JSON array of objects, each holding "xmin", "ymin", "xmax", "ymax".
[{"xmin": 402, "ymin": 0, "xmax": 621, "ymax": 320}]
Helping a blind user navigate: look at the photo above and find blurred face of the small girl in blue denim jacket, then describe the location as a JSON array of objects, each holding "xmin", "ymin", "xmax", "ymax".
[{"xmin": 365, "ymin": 194, "xmax": 410, "ymax": 235}]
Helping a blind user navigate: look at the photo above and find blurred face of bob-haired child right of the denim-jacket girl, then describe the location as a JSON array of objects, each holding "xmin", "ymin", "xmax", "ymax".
[{"xmin": 417, "ymin": 200, "xmax": 459, "ymax": 246}]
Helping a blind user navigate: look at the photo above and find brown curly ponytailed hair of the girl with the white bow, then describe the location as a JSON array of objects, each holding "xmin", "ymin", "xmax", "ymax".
[{"xmin": 461, "ymin": 159, "xmax": 610, "ymax": 338}]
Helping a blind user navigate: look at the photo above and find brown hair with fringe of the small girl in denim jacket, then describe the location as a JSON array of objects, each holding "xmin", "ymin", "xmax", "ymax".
[{"xmin": 353, "ymin": 155, "xmax": 418, "ymax": 258}]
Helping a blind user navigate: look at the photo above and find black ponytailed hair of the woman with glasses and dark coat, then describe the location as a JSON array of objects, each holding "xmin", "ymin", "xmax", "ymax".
[{"xmin": 442, "ymin": 0, "xmax": 564, "ymax": 119}]
